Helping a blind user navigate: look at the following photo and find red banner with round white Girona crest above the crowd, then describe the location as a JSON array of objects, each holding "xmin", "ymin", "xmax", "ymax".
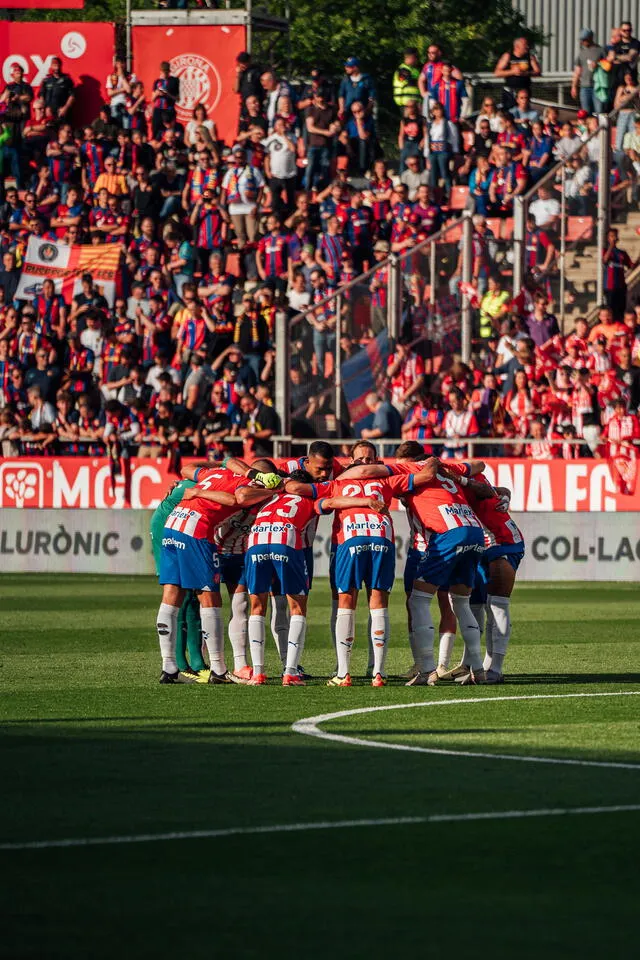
[{"xmin": 132, "ymin": 26, "xmax": 246, "ymax": 144}]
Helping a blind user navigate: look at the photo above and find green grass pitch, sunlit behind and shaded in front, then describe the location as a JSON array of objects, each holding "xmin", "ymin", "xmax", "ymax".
[{"xmin": 0, "ymin": 575, "xmax": 640, "ymax": 960}]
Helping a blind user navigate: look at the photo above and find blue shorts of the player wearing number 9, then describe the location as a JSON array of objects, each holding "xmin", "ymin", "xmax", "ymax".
[{"xmin": 418, "ymin": 527, "xmax": 484, "ymax": 588}]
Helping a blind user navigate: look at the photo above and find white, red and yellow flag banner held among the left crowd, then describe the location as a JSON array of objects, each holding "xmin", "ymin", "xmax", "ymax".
[{"xmin": 16, "ymin": 237, "xmax": 122, "ymax": 307}]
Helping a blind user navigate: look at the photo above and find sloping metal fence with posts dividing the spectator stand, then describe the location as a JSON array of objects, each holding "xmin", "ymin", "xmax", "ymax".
[{"xmin": 276, "ymin": 84, "xmax": 640, "ymax": 452}]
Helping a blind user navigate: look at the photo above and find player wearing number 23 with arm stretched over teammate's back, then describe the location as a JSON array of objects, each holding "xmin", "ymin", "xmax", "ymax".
[{"xmin": 245, "ymin": 461, "xmax": 380, "ymax": 687}]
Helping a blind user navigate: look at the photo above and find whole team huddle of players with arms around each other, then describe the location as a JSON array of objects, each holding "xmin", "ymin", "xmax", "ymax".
[{"xmin": 151, "ymin": 440, "xmax": 524, "ymax": 687}]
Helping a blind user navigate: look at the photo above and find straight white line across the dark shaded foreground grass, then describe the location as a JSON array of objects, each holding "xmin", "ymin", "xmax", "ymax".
[{"xmin": 0, "ymin": 803, "xmax": 640, "ymax": 851}]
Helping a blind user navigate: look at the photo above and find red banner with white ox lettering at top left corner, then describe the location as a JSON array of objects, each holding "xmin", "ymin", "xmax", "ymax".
[{"xmin": 0, "ymin": 20, "xmax": 114, "ymax": 124}]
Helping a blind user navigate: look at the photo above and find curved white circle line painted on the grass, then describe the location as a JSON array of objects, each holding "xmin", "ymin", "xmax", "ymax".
[{"xmin": 291, "ymin": 690, "xmax": 640, "ymax": 770}]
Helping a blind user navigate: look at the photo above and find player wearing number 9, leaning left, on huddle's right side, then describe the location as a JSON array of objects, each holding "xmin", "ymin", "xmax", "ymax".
[{"xmin": 393, "ymin": 459, "xmax": 487, "ymax": 686}]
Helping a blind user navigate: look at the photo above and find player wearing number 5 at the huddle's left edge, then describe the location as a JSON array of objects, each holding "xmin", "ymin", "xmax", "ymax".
[{"xmin": 156, "ymin": 468, "xmax": 270, "ymax": 683}]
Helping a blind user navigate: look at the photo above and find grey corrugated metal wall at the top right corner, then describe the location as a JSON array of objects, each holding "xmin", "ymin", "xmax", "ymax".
[{"xmin": 512, "ymin": 0, "xmax": 640, "ymax": 73}]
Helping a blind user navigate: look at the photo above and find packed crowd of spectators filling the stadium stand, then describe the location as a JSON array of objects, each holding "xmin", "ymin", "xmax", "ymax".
[{"xmin": 0, "ymin": 24, "xmax": 640, "ymax": 459}]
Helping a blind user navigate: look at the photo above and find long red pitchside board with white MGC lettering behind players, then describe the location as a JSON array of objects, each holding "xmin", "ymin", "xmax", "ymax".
[{"xmin": 0, "ymin": 457, "xmax": 640, "ymax": 513}]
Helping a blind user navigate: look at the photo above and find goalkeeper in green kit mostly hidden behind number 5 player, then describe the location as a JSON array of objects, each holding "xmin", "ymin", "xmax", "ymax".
[{"xmin": 150, "ymin": 479, "xmax": 209, "ymax": 681}]
